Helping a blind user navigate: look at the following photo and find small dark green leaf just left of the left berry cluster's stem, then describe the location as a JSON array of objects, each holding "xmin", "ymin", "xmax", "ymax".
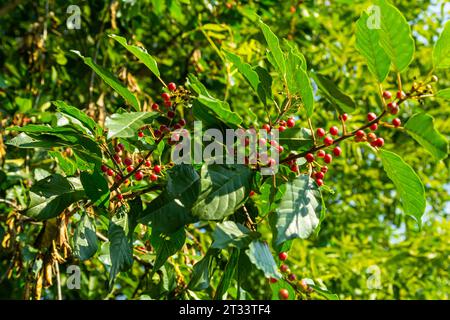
[{"xmin": 80, "ymin": 170, "xmax": 109, "ymax": 207}]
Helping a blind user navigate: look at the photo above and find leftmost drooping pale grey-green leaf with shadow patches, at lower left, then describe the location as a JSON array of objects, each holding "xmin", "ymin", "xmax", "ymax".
[{"xmin": 73, "ymin": 212, "xmax": 98, "ymax": 261}]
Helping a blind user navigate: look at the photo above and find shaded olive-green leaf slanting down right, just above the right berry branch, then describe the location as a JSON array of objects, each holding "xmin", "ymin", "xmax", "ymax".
[{"xmin": 312, "ymin": 73, "xmax": 356, "ymax": 114}]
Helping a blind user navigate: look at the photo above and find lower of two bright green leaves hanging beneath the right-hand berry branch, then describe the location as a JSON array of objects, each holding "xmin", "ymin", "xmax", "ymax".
[{"xmin": 380, "ymin": 149, "xmax": 426, "ymax": 227}]
